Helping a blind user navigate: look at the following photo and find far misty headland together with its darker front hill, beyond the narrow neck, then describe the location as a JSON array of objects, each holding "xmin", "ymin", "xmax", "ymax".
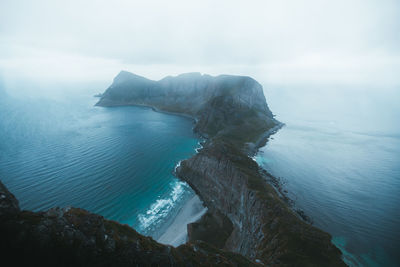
[{"xmin": 96, "ymin": 71, "xmax": 277, "ymax": 142}]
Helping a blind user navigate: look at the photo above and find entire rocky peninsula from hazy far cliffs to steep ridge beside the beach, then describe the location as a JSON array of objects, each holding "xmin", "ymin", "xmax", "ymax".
[{"xmin": 97, "ymin": 72, "xmax": 344, "ymax": 266}]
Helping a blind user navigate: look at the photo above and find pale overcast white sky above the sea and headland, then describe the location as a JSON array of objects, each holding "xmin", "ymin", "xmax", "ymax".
[{"xmin": 0, "ymin": 0, "xmax": 400, "ymax": 86}]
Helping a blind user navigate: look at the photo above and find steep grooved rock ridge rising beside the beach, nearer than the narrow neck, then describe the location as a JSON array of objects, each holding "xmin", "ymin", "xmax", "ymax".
[{"xmin": 177, "ymin": 144, "xmax": 343, "ymax": 266}]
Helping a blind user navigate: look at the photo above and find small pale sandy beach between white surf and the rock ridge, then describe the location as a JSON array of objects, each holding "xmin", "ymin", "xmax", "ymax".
[{"xmin": 157, "ymin": 195, "xmax": 207, "ymax": 247}]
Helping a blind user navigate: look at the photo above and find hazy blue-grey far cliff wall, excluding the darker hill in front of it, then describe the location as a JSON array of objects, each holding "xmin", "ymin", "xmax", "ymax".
[{"xmin": 98, "ymin": 71, "xmax": 272, "ymax": 115}]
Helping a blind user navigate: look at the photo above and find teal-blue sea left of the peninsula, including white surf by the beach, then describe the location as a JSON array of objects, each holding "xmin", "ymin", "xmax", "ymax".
[{"xmin": 0, "ymin": 91, "xmax": 198, "ymax": 236}]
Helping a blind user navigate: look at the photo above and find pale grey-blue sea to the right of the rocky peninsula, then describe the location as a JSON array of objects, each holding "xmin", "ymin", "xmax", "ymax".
[{"xmin": 256, "ymin": 88, "xmax": 400, "ymax": 266}]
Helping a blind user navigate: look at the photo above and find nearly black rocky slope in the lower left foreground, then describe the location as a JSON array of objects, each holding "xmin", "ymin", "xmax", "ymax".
[{"xmin": 0, "ymin": 182, "xmax": 256, "ymax": 266}]
